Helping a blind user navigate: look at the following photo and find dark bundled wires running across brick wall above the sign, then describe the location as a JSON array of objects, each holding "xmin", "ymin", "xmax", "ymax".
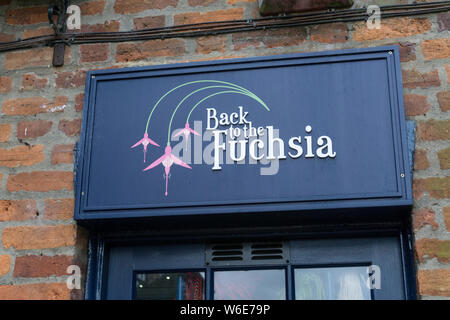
[{"xmin": 0, "ymin": 1, "xmax": 450, "ymax": 52}]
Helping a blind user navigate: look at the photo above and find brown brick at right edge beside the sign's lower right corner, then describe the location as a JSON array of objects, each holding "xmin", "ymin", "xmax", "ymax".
[{"xmin": 413, "ymin": 177, "xmax": 450, "ymax": 200}]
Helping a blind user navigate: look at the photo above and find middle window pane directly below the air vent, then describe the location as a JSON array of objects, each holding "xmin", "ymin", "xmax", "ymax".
[{"xmin": 214, "ymin": 269, "xmax": 286, "ymax": 300}]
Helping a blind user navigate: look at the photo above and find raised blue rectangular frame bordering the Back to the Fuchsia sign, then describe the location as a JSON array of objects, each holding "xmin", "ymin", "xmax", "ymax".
[{"xmin": 74, "ymin": 46, "xmax": 413, "ymax": 222}]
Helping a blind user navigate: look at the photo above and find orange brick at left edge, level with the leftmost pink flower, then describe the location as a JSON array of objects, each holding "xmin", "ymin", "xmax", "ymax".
[{"xmin": 0, "ymin": 144, "xmax": 45, "ymax": 168}]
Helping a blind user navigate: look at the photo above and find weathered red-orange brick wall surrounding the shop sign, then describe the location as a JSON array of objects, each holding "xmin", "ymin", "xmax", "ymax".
[{"xmin": 0, "ymin": 0, "xmax": 450, "ymax": 299}]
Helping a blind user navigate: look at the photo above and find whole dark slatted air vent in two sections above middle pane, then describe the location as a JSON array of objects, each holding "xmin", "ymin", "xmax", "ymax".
[{"xmin": 206, "ymin": 241, "xmax": 289, "ymax": 266}]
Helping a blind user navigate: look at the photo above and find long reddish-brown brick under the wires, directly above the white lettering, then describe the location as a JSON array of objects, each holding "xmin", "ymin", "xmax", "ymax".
[{"xmin": 232, "ymin": 27, "xmax": 307, "ymax": 50}]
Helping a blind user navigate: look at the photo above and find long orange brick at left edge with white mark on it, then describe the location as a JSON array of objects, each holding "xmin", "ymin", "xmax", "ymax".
[{"xmin": 2, "ymin": 96, "xmax": 67, "ymax": 116}]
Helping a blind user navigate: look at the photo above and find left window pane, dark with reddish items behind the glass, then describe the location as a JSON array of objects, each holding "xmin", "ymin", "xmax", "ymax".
[{"xmin": 136, "ymin": 272, "xmax": 205, "ymax": 300}]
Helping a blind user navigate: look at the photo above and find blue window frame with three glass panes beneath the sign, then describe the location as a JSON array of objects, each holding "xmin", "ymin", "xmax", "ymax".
[{"xmin": 98, "ymin": 233, "xmax": 415, "ymax": 300}]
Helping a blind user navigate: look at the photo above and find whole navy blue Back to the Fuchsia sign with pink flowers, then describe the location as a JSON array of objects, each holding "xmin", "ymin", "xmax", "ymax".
[{"xmin": 76, "ymin": 47, "xmax": 411, "ymax": 220}]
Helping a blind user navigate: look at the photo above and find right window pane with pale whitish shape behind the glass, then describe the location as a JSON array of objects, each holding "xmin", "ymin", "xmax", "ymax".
[{"xmin": 294, "ymin": 267, "xmax": 371, "ymax": 300}]
